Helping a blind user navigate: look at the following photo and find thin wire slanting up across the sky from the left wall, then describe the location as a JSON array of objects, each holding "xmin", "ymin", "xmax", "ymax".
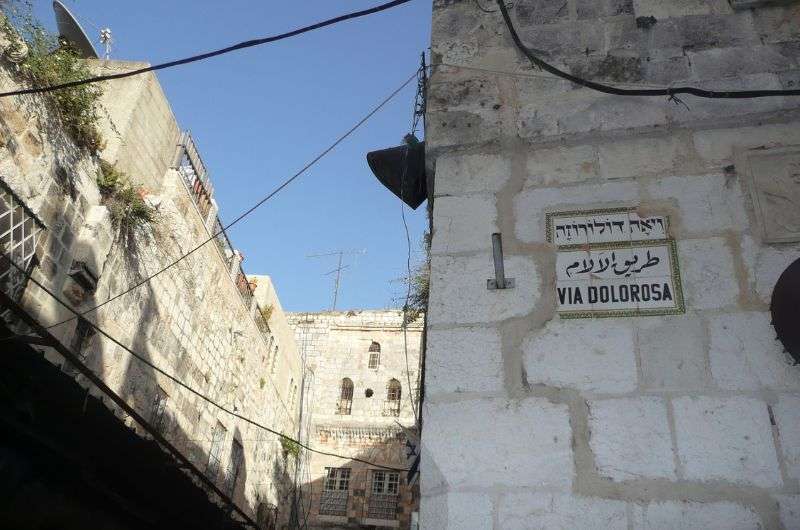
[{"xmin": 0, "ymin": 72, "xmax": 417, "ymax": 341}]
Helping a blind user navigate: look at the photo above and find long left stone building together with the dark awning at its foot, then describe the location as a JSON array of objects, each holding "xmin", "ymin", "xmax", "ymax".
[{"xmin": 0, "ymin": 31, "xmax": 303, "ymax": 528}]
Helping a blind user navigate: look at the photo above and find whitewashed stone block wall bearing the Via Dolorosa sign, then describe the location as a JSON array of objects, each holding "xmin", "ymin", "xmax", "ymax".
[{"xmin": 420, "ymin": 0, "xmax": 800, "ymax": 530}]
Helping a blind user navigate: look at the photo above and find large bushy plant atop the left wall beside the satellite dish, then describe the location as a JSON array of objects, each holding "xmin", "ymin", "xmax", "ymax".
[{"xmin": 0, "ymin": 0, "xmax": 103, "ymax": 154}]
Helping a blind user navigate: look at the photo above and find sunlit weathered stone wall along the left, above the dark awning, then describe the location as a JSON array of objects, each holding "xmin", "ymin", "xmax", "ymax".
[{"xmin": 0, "ymin": 52, "xmax": 301, "ymax": 520}]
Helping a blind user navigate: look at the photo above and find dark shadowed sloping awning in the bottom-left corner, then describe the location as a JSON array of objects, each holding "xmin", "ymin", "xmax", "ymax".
[{"xmin": 0, "ymin": 324, "xmax": 250, "ymax": 530}]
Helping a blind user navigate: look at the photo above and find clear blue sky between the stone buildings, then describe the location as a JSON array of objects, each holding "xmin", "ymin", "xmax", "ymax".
[{"xmin": 35, "ymin": 0, "xmax": 431, "ymax": 311}]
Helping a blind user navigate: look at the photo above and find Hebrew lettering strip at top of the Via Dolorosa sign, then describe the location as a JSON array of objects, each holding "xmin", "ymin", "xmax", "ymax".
[{"xmin": 548, "ymin": 212, "xmax": 668, "ymax": 246}]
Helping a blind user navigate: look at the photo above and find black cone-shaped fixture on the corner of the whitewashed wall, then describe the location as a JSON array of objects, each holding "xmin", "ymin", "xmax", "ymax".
[{"xmin": 367, "ymin": 142, "xmax": 428, "ymax": 210}]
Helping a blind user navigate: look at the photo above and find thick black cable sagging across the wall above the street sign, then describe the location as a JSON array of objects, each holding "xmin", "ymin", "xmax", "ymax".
[{"xmin": 496, "ymin": 0, "xmax": 800, "ymax": 99}]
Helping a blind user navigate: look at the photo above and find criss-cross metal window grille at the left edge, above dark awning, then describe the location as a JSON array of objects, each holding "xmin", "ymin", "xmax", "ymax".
[{"xmin": 0, "ymin": 181, "xmax": 44, "ymax": 294}]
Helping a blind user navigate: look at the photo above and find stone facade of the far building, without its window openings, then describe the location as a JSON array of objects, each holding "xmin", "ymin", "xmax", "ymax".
[{"xmin": 288, "ymin": 310, "xmax": 422, "ymax": 528}]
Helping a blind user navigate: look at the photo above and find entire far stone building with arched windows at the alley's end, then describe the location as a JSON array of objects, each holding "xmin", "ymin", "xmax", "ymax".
[{"xmin": 289, "ymin": 310, "xmax": 422, "ymax": 528}]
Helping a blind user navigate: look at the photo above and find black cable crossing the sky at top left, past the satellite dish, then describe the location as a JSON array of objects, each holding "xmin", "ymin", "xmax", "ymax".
[{"xmin": 0, "ymin": 0, "xmax": 411, "ymax": 98}]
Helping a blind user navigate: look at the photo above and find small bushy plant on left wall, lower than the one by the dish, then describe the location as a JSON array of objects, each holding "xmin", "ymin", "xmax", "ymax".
[{"xmin": 97, "ymin": 160, "xmax": 157, "ymax": 238}]
